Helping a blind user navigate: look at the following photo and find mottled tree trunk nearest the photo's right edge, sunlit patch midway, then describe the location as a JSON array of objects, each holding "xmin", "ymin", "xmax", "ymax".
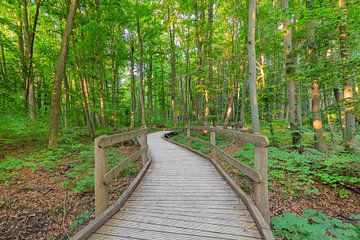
[{"xmin": 339, "ymin": 0, "xmax": 356, "ymax": 152}]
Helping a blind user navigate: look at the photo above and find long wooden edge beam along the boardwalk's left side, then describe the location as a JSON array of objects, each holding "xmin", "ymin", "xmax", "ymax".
[{"xmin": 73, "ymin": 159, "xmax": 151, "ymax": 240}]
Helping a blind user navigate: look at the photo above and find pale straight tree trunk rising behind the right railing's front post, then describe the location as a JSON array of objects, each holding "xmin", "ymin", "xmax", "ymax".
[{"xmin": 248, "ymin": 0, "xmax": 260, "ymax": 133}]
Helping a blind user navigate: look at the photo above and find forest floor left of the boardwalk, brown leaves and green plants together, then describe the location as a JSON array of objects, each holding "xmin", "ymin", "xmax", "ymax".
[{"xmin": 0, "ymin": 129, "xmax": 141, "ymax": 240}]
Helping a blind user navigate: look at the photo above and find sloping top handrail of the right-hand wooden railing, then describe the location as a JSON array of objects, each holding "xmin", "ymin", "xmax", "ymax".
[{"xmin": 190, "ymin": 126, "xmax": 269, "ymax": 147}]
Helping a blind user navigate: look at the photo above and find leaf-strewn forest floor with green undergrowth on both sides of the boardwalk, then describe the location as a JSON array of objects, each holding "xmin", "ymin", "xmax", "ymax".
[{"xmin": 0, "ymin": 120, "xmax": 360, "ymax": 240}]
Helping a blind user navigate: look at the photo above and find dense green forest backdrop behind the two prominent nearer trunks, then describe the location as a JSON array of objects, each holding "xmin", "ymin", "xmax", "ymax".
[{"xmin": 0, "ymin": 0, "xmax": 359, "ymax": 151}]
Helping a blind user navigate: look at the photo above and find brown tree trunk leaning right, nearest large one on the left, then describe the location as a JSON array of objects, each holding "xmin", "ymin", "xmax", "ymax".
[{"xmin": 49, "ymin": 0, "xmax": 78, "ymax": 147}]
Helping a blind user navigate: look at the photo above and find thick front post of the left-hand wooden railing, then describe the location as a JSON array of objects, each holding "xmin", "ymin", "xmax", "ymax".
[{"xmin": 94, "ymin": 136, "xmax": 109, "ymax": 217}]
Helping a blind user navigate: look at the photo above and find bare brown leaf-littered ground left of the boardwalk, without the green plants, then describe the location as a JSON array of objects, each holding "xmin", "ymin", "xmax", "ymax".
[{"xmin": 0, "ymin": 143, "xmax": 139, "ymax": 240}]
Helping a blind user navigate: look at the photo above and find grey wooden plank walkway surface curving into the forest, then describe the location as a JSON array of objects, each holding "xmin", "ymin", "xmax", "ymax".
[{"xmin": 89, "ymin": 132, "xmax": 262, "ymax": 240}]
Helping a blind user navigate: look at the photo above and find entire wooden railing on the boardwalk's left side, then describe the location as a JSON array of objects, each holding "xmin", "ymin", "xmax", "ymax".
[{"xmin": 94, "ymin": 128, "xmax": 149, "ymax": 217}]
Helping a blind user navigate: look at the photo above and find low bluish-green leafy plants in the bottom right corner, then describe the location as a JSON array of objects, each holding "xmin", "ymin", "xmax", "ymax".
[{"xmin": 271, "ymin": 209, "xmax": 360, "ymax": 240}]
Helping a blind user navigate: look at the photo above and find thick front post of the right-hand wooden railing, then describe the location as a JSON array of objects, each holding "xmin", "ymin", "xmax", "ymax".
[{"xmin": 254, "ymin": 145, "xmax": 270, "ymax": 223}]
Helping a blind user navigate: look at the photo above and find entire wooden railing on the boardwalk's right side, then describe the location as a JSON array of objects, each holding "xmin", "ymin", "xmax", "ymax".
[{"xmin": 187, "ymin": 126, "xmax": 270, "ymax": 222}]
